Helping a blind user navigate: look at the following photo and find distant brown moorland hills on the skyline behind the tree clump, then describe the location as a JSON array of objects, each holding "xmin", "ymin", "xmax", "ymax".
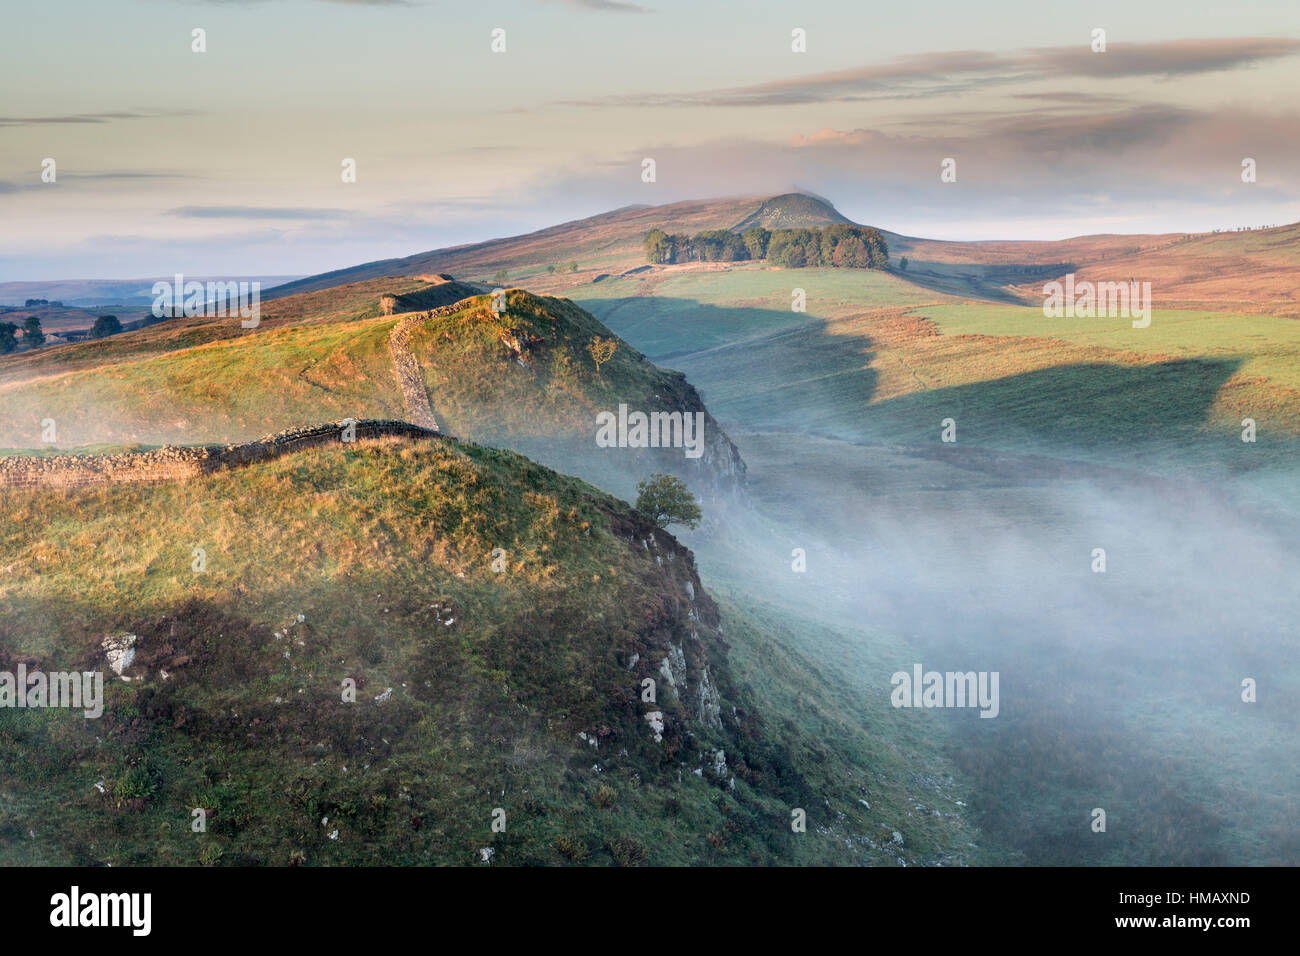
[{"xmin": 268, "ymin": 193, "xmax": 1300, "ymax": 317}]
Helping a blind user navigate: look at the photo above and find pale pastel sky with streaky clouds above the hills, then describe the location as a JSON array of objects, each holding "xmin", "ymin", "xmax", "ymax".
[{"xmin": 0, "ymin": 0, "xmax": 1300, "ymax": 281}]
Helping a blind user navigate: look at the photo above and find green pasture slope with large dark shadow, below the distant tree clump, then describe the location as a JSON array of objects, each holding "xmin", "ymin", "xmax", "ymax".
[{"xmin": 580, "ymin": 269, "xmax": 1300, "ymax": 470}]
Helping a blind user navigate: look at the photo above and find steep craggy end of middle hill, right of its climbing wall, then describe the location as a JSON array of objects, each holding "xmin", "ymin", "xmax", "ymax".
[{"xmin": 389, "ymin": 289, "xmax": 746, "ymax": 499}]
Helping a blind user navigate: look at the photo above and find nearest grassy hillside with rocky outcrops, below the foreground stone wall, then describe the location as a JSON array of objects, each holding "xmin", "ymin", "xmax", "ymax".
[{"xmin": 0, "ymin": 442, "xmax": 970, "ymax": 865}]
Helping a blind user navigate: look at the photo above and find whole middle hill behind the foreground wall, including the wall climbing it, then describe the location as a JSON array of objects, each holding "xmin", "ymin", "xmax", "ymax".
[{"xmin": 0, "ymin": 286, "xmax": 745, "ymax": 498}]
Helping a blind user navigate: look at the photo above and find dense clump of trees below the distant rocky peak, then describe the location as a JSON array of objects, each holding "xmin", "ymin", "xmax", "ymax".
[{"xmin": 645, "ymin": 224, "xmax": 889, "ymax": 269}]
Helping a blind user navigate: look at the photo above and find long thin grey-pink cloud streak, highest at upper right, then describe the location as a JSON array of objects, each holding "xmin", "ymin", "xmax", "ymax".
[{"xmin": 566, "ymin": 36, "xmax": 1300, "ymax": 107}]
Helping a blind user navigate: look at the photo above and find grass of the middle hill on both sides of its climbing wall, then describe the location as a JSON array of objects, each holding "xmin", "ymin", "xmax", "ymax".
[{"xmin": 0, "ymin": 284, "xmax": 743, "ymax": 497}]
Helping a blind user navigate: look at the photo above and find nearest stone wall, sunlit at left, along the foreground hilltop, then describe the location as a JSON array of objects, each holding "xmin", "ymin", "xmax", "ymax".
[{"xmin": 0, "ymin": 419, "xmax": 446, "ymax": 488}]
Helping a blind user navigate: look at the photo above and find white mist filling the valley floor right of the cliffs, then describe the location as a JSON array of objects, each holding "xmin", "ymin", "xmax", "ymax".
[{"xmin": 686, "ymin": 442, "xmax": 1300, "ymax": 865}]
